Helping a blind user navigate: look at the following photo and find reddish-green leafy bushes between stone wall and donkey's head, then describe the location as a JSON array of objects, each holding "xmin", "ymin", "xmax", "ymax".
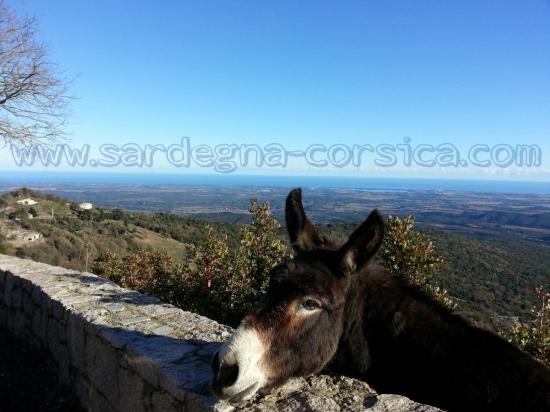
[{"xmin": 93, "ymin": 200, "xmax": 289, "ymax": 325}]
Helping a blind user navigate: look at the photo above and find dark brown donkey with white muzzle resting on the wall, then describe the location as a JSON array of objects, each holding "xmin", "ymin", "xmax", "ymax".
[{"xmin": 212, "ymin": 189, "xmax": 550, "ymax": 411}]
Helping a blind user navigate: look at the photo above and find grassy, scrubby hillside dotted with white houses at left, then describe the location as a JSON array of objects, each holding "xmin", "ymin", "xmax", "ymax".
[{"xmin": 0, "ymin": 190, "xmax": 236, "ymax": 271}]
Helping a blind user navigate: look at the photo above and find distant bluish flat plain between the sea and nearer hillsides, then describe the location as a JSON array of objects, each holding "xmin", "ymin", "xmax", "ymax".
[{"xmin": 8, "ymin": 184, "xmax": 550, "ymax": 246}]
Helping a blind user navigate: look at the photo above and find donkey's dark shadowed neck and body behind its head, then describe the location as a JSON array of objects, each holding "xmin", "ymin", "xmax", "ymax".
[{"xmin": 333, "ymin": 266, "xmax": 550, "ymax": 410}]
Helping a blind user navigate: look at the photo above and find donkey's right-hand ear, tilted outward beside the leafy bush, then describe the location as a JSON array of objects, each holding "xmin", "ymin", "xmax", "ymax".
[{"xmin": 340, "ymin": 209, "xmax": 384, "ymax": 273}]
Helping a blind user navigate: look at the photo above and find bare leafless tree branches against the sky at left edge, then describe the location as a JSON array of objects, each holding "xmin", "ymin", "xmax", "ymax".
[{"xmin": 0, "ymin": 0, "xmax": 70, "ymax": 145}]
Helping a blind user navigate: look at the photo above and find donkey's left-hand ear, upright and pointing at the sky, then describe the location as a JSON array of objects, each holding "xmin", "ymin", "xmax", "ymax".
[{"xmin": 285, "ymin": 189, "xmax": 323, "ymax": 252}]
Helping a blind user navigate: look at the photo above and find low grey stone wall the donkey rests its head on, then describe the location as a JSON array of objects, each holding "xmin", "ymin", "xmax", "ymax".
[{"xmin": 0, "ymin": 255, "xmax": 437, "ymax": 412}]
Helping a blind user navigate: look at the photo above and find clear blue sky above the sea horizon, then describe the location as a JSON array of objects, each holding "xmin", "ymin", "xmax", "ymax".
[{"xmin": 0, "ymin": 0, "xmax": 550, "ymax": 180}]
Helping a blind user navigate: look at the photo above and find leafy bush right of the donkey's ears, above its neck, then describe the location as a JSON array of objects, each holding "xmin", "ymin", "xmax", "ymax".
[{"xmin": 378, "ymin": 216, "xmax": 456, "ymax": 309}]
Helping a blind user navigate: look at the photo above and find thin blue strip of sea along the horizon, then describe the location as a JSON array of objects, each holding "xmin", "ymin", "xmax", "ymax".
[{"xmin": 0, "ymin": 171, "xmax": 550, "ymax": 194}]
